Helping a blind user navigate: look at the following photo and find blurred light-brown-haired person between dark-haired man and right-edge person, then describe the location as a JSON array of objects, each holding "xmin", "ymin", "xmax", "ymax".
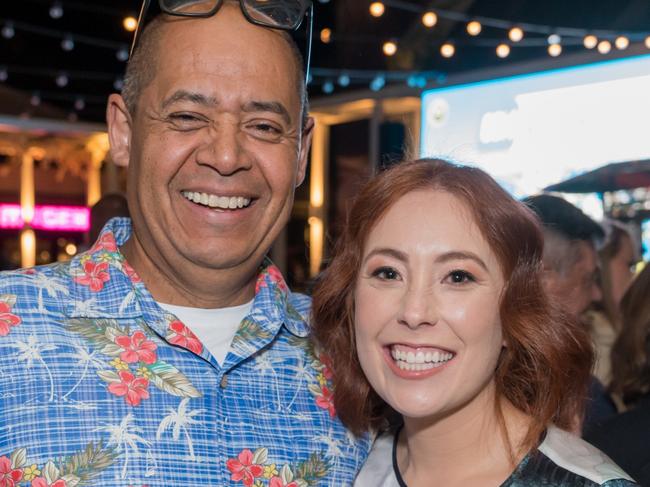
[{"xmin": 585, "ymin": 220, "xmax": 640, "ymax": 387}]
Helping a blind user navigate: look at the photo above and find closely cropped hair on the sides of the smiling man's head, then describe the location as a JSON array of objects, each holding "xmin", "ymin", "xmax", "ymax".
[{"xmin": 122, "ymin": 12, "xmax": 309, "ymax": 127}]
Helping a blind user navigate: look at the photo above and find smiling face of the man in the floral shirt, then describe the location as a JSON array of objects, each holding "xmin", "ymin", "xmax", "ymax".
[{"xmin": 109, "ymin": 4, "xmax": 311, "ymax": 282}]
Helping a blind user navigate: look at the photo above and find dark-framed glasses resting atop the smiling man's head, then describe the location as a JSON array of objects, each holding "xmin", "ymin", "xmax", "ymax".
[{"xmin": 129, "ymin": 0, "xmax": 314, "ymax": 83}]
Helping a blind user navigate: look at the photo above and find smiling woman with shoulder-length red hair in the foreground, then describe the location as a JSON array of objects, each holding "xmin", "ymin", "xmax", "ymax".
[{"xmin": 313, "ymin": 160, "xmax": 634, "ymax": 487}]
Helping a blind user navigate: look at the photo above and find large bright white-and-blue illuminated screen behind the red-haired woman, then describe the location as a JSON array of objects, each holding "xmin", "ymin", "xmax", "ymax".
[{"xmin": 421, "ymin": 55, "xmax": 650, "ymax": 197}]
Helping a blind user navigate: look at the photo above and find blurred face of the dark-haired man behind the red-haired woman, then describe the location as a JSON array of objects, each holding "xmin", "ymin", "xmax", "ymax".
[{"xmin": 544, "ymin": 242, "xmax": 601, "ymax": 317}]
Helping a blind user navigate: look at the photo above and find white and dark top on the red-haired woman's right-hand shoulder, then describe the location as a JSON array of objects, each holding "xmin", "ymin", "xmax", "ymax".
[{"xmin": 506, "ymin": 426, "xmax": 637, "ymax": 487}]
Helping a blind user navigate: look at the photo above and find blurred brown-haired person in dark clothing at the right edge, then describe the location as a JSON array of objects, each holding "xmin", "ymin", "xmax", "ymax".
[{"xmin": 585, "ymin": 265, "xmax": 650, "ymax": 486}]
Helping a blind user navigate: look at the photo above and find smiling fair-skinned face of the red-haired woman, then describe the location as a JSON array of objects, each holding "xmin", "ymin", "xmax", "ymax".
[{"xmin": 355, "ymin": 190, "xmax": 504, "ymax": 424}]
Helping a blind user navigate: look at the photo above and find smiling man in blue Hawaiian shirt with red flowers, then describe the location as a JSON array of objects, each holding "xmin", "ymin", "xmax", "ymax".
[{"xmin": 0, "ymin": 2, "xmax": 369, "ymax": 487}]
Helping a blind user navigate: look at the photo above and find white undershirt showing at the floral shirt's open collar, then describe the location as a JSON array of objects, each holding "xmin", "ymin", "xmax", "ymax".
[{"xmin": 158, "ymin": 300, "xmax": 253, "ymax": 365}]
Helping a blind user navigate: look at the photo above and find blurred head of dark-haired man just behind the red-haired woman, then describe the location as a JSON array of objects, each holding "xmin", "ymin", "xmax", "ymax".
[{"xmin": 524, "ymin": 194, "xmax": 604, "ymax": 317}]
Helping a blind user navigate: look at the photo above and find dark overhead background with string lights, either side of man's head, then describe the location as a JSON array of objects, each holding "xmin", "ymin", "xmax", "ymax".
[{"xmin": 0, "ymin": 0, "xmax": 650, "ymax": 122}]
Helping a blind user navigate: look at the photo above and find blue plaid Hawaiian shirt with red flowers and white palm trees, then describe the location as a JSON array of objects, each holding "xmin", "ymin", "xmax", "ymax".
[{"xmin": 0, "ymin": 218, "xmax": 370, "ymax": 487}]
